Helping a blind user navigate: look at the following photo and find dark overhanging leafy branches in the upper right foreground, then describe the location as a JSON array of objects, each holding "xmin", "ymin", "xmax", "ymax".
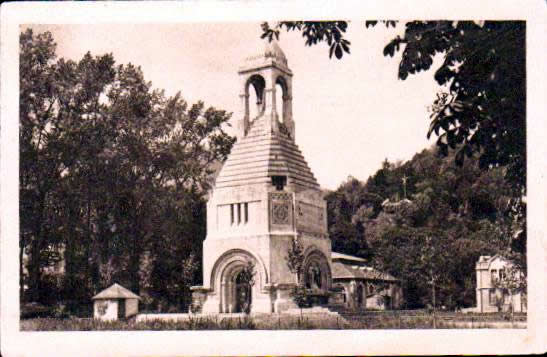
[{"xmin": 262, "ymin": 21, "xmax": 526, "ymax": 195}]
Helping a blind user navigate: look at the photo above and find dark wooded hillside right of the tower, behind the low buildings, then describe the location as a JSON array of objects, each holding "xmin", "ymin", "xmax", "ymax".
[{"xmin": 326, "ymin": 148, "xmax": 526, "ymax": 308}]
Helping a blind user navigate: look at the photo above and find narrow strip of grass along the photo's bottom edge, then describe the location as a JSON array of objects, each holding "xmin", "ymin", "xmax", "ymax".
[{"xmin": 20, "ymin": 313, "xmax": 526, "ymax": 331}]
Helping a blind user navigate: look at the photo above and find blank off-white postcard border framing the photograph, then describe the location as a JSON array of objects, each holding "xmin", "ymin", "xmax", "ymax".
[{"xmin": 0, "ymin": 0, "xmax": 547, "ymax": 356}]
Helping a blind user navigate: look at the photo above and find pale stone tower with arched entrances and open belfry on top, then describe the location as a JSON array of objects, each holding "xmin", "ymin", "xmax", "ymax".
[{"xmin": 192, "ymin": 41, "xmax": 402, "ymax": 313}]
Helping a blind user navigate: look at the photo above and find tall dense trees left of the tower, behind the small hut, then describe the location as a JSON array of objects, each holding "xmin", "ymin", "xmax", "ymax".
[{"xmin": 19, "ymin": 30, "xmax": 234, "ymax": 310}]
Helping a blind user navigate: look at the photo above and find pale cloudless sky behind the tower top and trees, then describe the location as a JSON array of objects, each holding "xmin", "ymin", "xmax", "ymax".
[{"xmin": 28, "ymin": 22, "xmax": 439, "ymax": 189}]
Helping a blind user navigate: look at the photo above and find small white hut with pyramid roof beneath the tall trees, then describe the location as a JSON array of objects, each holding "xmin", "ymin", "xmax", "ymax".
[{"xmin": 92, "ymin": 284, "xmax": 140, "ymax": 320}]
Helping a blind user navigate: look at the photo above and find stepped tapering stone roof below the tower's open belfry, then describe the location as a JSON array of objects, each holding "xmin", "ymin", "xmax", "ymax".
[{"xmin": 215, "ymin": 116, "xmax": 319, "ymax": 189}]
